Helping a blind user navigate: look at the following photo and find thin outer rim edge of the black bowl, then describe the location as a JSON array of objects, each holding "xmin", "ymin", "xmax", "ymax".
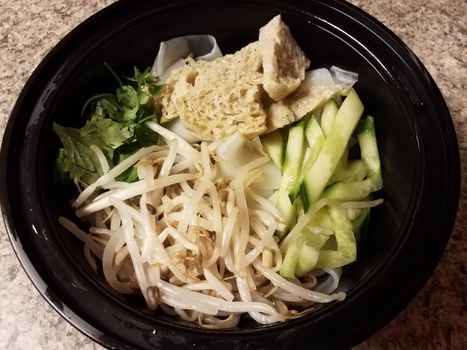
[{"xmin": 0, "ymin": 0, "xmax": 460, "ymax": 347}]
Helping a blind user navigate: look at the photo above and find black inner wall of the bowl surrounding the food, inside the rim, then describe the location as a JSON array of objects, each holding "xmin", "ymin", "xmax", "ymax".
[{"xmin": 38, "ymin": 0, "xmax": 416, "ymax": 331}]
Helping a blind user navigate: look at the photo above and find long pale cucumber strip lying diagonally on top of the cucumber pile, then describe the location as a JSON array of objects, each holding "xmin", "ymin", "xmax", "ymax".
[{"xmin": 303, "ymin": 89, "xmax": 363, "ymax": 209}]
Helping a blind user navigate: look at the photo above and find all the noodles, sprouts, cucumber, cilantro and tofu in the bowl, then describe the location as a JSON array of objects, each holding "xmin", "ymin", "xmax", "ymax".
[{"xmin": 54, "ymin": 16, "xmax": 382, "ymax": 329}]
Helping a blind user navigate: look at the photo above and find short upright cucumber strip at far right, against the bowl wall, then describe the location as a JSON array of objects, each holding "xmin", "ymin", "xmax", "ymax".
[{"xmin": 358, "ymin": 116, "xmax": 383, "ymax": 189}]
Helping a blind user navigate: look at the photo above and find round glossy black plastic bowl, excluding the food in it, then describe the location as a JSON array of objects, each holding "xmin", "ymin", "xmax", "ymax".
[{"xmin": 0, "ymin": 0, "xmax": 460, "ymax": 349}]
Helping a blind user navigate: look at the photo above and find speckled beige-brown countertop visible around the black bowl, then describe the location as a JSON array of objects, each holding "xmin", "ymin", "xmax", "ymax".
[{"xmin": 0, "ymin": 0, "xmax": 467, "ymax": 350}]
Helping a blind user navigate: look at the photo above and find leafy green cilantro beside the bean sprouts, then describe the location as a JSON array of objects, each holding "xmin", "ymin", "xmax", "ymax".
[{"xmin": 53, "ymin": 64, "xmax": 163, "ymax": 186}]
